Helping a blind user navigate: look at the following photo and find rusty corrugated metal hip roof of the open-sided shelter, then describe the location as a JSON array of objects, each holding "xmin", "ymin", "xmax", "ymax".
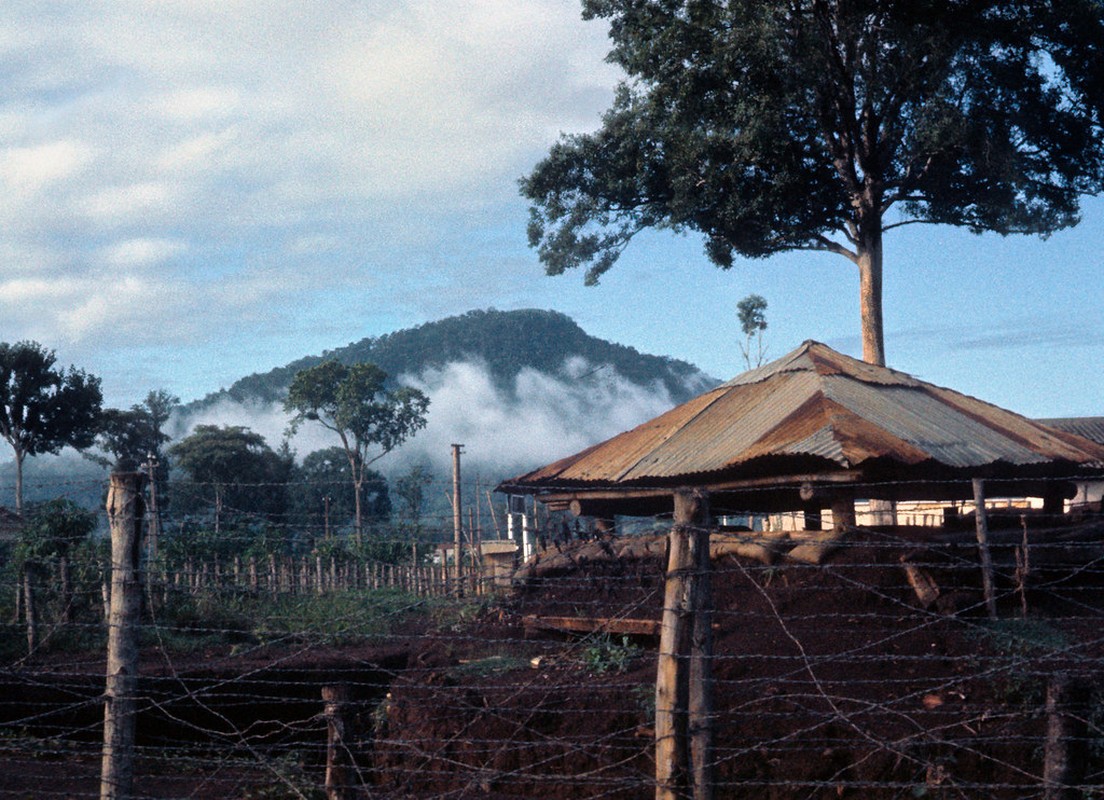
[{"xmin": 501, "ymin": 341, "xmax": 1104, "ymax": 492}]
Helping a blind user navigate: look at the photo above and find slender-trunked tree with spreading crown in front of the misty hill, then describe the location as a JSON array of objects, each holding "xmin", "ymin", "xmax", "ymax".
[{"xmin": 284, "ymin": 360, "xmax": 429, "ymax": 543}]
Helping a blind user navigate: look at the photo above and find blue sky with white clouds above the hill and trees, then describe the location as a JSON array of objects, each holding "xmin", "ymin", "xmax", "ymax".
[{"xmin": 0, "ymin": 0, "xmax": 1104, "ymax": 416}]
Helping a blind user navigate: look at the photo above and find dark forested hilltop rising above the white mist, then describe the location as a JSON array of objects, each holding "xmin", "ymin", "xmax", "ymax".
[{"xmin": 190, "ymin": 310, "xmax": 712, "ymax": 410}]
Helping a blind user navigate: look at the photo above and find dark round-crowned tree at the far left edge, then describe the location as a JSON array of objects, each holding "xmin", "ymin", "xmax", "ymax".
[{"xmin": 0, "ymin": 341, "xmax": 103, "ymax": 513}]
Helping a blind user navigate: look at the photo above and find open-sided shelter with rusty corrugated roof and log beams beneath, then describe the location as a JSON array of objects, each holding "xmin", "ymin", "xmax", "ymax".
[{"xmin": 499, "ymin": 341, "xmax": 1104, "ymax": 518}]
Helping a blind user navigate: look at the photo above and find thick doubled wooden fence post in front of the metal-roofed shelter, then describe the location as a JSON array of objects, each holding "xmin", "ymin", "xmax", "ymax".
[{"xmin": 656, "ymin": 490, "xmax": 713, "ymax": 800}]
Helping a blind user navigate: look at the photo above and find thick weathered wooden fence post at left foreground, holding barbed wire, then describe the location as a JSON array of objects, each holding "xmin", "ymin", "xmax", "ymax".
[{"xmin": 99, "ymin": 472, "xmax": 142, "ymax": 800}]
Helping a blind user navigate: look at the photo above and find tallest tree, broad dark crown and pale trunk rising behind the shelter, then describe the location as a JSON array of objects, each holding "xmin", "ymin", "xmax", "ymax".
[{"xmin": 521, "ymin": 0, "xmax": 1104, "ymax": 364}]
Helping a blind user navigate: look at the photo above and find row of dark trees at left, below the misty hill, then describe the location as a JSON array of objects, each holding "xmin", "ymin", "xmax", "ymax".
[{"xmin": 0, "ymin": 341, "xmax": 429, "ymax": 542}]
